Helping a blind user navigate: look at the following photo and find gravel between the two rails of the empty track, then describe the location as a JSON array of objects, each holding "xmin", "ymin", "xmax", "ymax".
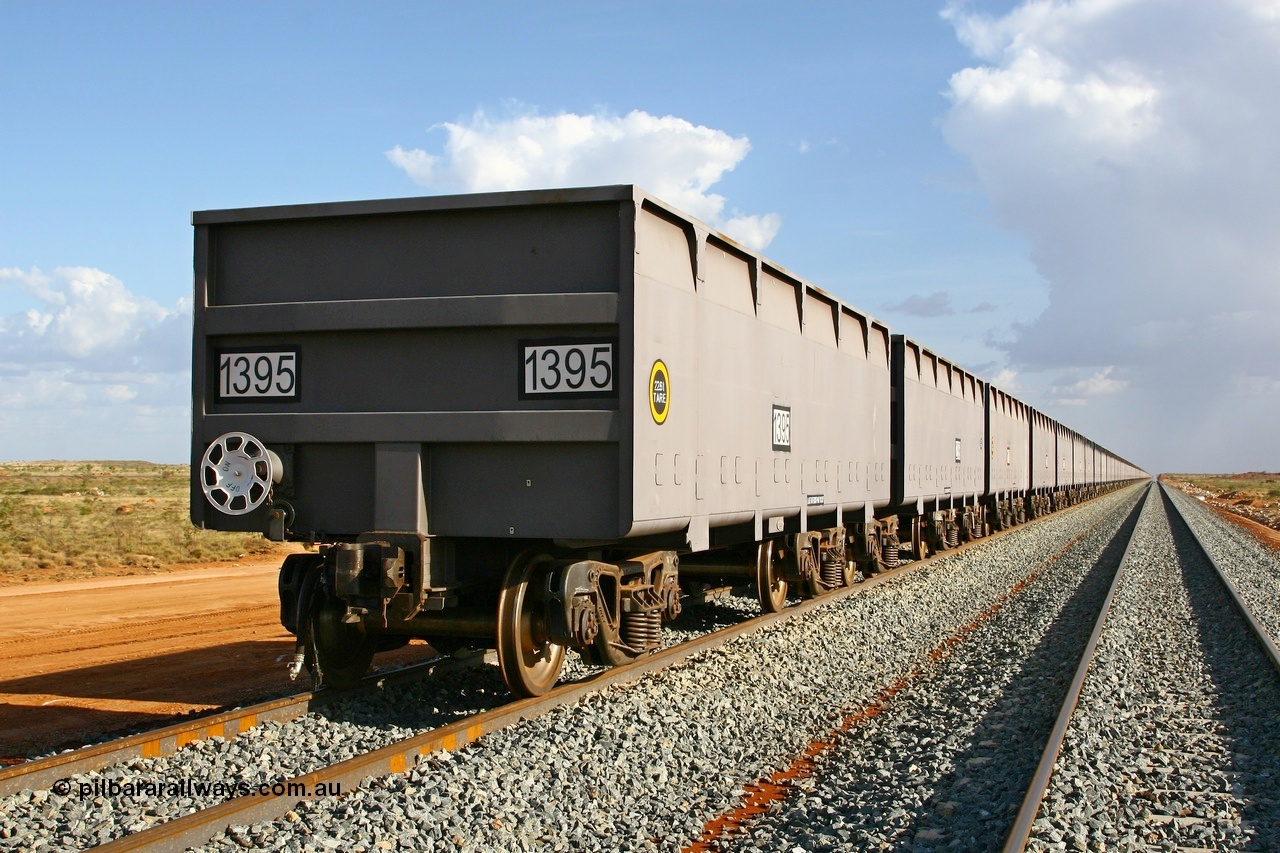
[{"xmin": 1032, "ymin": 481, "xmax": 1280, "ymax": 850}]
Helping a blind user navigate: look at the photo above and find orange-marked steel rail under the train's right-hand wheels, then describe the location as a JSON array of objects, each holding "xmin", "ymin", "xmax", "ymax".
[{"xmin": 96, "ymin": 481, "xmax": 1141, "ymax": 853}]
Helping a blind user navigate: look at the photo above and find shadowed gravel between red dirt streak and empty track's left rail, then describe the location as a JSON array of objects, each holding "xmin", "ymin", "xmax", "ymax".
[{"xmin": 733, "ymin": 492, "xmax": 1152, "ymax": 850}]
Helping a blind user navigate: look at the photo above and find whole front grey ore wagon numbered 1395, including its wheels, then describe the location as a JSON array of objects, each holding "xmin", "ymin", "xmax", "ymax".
[{"xmin": 191, "ymin": 186, "xmax": 890, "ymax": 693}]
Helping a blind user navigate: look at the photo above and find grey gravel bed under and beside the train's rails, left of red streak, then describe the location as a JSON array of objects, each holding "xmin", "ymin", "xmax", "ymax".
[{"xmin": 0, "ymin": 481, "xmax": 1135, "ymax": 850}]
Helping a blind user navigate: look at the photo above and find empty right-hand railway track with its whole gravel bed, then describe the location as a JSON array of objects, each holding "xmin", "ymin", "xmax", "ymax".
[{"xmin": 695, "ymin": 488, "xmax": 1280, "ymax": 850}]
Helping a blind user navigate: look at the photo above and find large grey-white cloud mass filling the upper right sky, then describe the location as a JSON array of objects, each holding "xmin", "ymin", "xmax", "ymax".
[{"xmin": 943, "ymin": 0, "xmax": 1280, "ymax": 466}]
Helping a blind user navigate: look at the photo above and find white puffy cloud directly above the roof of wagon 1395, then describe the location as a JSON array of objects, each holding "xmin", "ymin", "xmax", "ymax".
[{"xmin": 387, "ymin": 104, "xmax": 782, "ymax": 250}]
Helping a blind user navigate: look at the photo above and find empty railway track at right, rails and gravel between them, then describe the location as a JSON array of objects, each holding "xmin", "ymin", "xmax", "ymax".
[{"xmin": 1005, "ymin": 484, "xmax": 1280, "ymax": 852}]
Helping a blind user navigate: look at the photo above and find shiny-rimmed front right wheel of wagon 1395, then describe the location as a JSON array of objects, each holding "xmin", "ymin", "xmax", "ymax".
[{"xmin": 498, "ymin": 555, "xmax": 564, "ymax": 697}]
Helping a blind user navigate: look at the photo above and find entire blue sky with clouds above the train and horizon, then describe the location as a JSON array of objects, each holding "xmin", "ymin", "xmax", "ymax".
[{"xmin": 0, "ymin": 0, "xmax": 1280, "ymax": 471}]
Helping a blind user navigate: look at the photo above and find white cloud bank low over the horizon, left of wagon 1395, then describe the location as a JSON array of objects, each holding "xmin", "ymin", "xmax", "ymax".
[{"xmin": 0, "ymin": 266, "xmax": 191, "ymax": 459}]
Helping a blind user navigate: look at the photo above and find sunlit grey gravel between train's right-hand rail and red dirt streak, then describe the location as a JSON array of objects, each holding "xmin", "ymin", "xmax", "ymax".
[{"xmin": 186, "ymin": 491, "xmax": 1134, "ymax": 850}]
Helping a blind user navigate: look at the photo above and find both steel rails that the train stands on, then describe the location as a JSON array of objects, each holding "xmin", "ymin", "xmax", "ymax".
[{"xmin": 0, "ymin": 489, "xmax": 1136, "ymax": 849}]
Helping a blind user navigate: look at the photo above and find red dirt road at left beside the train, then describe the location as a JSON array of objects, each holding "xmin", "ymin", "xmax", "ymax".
[{"xmin": 0, "ymin": 557, "xmax": 430, "ymax": 763}]
